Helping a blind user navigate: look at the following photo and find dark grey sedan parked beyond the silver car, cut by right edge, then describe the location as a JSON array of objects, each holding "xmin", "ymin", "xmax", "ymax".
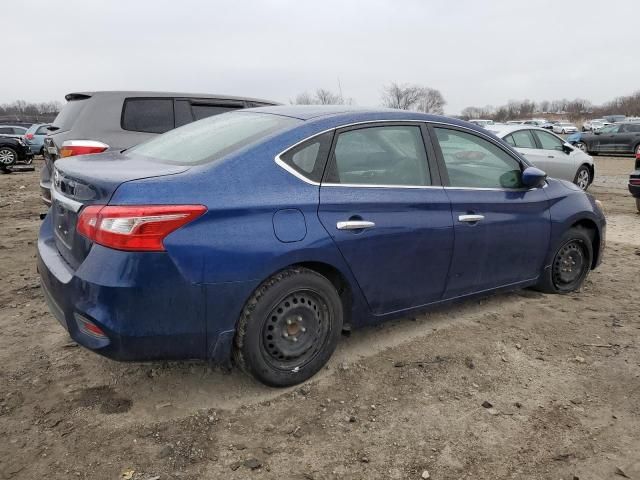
[{"xmin": 575, "ymin": 122, "xmax": 640, "ymax": 154}]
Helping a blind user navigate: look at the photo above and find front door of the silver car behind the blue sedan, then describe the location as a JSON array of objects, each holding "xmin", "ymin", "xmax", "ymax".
[{"xmin": 525, "ymin": 130, "xmax": 579, "ymax": 182}]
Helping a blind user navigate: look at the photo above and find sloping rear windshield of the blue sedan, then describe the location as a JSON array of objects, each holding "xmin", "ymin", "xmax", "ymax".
[{"xmin": 129, "ymin": 112, "xmax": 302, "ymax": 165}]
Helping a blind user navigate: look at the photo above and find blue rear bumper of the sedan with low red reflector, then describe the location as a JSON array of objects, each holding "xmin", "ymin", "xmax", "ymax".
[{"xmin": 38, "ymin": 215, "xmax": 212, "ymax": 360}]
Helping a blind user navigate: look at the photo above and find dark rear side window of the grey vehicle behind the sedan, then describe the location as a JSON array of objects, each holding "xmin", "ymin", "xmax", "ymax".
[{"xmin": 122, "ymin": 98, "xmax": 175, "ymax": 133}]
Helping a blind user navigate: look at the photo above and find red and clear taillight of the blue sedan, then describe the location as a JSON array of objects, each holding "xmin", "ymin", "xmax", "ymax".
[{"xmin": 76, "ymin": 205, "xmax": 207, "ymax": 252}]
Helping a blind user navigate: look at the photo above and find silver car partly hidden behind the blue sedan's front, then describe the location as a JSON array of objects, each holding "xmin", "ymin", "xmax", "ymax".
[{"xmin": 488, "ymin": 125, "xmax": 595, "ymax": 190}]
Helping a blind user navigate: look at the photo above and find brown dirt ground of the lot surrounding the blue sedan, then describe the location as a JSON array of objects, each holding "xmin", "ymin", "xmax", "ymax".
[{"xmin": 0, "ymin": 157, "xmax": 640, "ymax": 480}]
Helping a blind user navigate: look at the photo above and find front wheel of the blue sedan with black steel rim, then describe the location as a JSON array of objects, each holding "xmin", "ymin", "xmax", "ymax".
[{"xmin": 536, "ymin": 227, "xmax": 593, "ymax": 294}]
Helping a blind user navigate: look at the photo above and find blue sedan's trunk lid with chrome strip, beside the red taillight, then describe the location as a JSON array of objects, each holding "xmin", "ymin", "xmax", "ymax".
[{"xmin": 50, "ymin": 152, "xmax": 189, "ymax": 270}]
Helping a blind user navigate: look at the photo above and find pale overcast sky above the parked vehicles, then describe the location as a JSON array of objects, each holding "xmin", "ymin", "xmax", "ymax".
[{"xmin": 0, "ymin": 0, "xmax": 640, "ymax": 114}]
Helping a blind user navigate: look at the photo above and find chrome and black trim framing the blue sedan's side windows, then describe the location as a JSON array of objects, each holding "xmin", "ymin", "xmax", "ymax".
[{"xmin": 273, "ymin": 119, "xmax": 528, "ymax": 192}]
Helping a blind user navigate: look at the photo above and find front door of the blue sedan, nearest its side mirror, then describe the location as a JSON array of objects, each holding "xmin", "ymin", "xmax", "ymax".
[{"xmin": 430, "ymin": 125, "xmax": 550, "ymax": 299}]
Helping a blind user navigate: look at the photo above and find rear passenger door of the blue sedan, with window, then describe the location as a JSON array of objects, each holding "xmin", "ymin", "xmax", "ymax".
[{"xmin": 318, "ymin": 122, "xmax": 453, "ymax": 315}]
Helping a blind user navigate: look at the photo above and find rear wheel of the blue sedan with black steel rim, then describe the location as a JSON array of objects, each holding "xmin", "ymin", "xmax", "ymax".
[{"xmin": 234, "ymin": 267, "xmax": 343, "ymax": 387}]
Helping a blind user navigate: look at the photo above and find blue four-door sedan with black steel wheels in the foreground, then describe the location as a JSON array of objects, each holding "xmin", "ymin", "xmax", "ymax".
[{"xmin": 38, "ymin": 106, "xmax": 605, "ymax": 386}]
